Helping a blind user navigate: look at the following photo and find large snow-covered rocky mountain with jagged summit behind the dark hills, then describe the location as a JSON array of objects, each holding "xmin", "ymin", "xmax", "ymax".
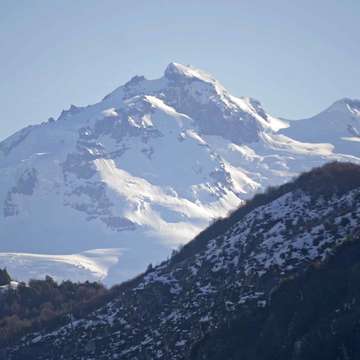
[{"xmin": 0, "ymin": 63, "xmax": 360, "ymax": 282}]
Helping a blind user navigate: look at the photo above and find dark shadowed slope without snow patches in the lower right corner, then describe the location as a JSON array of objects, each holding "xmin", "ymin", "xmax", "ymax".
[{"xmin": 190, "ymin": 236, "xmax": 360, "ymax": 360}]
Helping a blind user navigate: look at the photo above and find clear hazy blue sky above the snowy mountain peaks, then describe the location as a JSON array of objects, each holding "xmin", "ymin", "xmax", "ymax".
[{"xmin": 0, "ymin": 0, "xmax": 360, "ymax": 139}]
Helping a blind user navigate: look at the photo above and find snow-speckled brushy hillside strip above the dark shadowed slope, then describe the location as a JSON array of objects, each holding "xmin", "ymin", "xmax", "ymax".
[{"xmin": 6, "ymin": 163, "xmax": 360, "ymax": 360}]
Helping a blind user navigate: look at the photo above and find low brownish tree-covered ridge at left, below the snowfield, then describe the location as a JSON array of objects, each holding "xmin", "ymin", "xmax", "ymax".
[{"xmin": 0, "ymin": 269, "xmax": 110, "ymax": 347}]
